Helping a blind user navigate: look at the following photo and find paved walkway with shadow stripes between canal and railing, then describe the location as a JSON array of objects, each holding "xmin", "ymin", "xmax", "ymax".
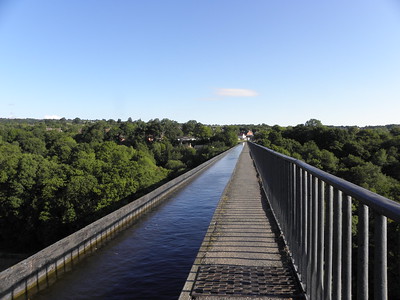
[{"xmin": 179, "ymin": 144, "xmax": 303, "ymax": 300}]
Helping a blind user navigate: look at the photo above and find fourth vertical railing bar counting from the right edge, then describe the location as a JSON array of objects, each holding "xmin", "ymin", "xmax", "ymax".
[{"xmin": 332, "ymin": 189, "xmax": 342, "ymax": 300}]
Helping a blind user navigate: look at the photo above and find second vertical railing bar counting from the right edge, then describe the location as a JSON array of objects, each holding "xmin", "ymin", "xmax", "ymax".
[{"xmin": 357, "ymin": 202, "xmax": 369, "ymax": 300}]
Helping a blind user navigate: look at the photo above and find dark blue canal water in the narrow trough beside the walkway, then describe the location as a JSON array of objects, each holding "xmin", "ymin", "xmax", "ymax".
[{"xmin": 33, "ymin": 146, "xmax": 243, "ymax": 300}]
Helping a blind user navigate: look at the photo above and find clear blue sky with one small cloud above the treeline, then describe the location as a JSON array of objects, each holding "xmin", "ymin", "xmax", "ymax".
[{"xmin": 0, "ymin": 0, "xmax": 400, "ymax": 126}]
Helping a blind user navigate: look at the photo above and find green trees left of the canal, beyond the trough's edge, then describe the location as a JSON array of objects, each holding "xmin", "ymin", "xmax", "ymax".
[{"xmin": 0, "ymin": 118, "xmax": 237, "ymax": 252}]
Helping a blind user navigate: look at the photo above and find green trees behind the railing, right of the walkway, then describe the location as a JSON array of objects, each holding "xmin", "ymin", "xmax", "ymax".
[{"xmin": 255, "ymin": 119, "xmax": 400, "ymax": 200}]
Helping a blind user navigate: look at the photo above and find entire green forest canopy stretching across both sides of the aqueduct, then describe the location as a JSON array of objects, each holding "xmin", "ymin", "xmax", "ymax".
[{"xmin": 0, "ymin": 118, "xmax": 400, "ymax": 252}]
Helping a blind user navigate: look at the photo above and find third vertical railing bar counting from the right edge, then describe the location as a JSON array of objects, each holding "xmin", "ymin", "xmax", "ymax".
[{"xmin": 342, "ymin": 195, "xmax": 352, "ymax": 300}]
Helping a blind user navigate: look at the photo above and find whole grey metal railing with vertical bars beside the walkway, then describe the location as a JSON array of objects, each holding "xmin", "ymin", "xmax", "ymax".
[{"xmin": 249, "ymin": 143, "xmax": 400, "ymax": 300}]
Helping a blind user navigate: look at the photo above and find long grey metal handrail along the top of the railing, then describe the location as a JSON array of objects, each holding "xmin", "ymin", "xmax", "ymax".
[{"xmin": 252, "ymin": 143, "xmax": 400, "ymax": 222}]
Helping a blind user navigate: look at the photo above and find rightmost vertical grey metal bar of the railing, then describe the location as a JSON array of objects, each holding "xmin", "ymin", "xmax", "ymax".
[{"xmin": 374, "ymin": 214, "xmax": 388, "ymax": 300}]
